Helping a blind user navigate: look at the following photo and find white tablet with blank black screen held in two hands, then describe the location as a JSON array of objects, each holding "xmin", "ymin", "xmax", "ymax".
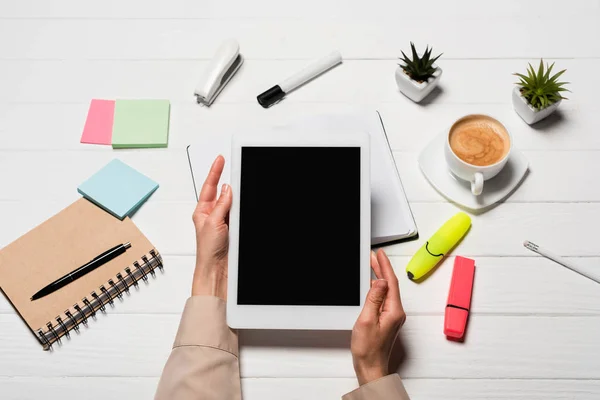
[{"xmin": 227, "ymin": 130, "xmax": 371, "ymax": 330}]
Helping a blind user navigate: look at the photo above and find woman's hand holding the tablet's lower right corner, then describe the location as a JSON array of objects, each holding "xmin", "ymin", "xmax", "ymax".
[{"xmin": 350, "ymin": 250, "xmax": 406, "ymax": 385}]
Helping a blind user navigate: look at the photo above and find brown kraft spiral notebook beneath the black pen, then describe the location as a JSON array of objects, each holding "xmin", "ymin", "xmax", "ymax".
[{"xmin": 0, "ymin": 199, "xmax": 162, "ymax": 350}]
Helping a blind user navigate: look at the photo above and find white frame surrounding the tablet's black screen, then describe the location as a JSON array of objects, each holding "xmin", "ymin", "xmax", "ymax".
[{"xmin": 227, "ymin": 129, "xmax": 371, "ymax": 330}]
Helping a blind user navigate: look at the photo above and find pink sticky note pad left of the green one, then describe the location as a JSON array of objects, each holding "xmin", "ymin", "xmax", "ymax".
[{"xmin": 81, "ymin": 99, "xmax": 115, "ymax": 144}]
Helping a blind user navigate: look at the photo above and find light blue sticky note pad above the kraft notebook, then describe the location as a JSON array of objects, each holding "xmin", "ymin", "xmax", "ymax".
[{"xmin": 77, "ymin": 159, "xmax": 158, "ymax": 219}]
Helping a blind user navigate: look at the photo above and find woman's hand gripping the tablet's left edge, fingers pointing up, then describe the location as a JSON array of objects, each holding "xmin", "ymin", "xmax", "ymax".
[{"xmin": 192, "ymin": 156, "xmax": 232, "ymax": 300}]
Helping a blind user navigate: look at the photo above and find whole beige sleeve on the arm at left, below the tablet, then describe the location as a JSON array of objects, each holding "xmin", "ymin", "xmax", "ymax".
[{"xmin": 155, "ymin": 296, "xmax": 242, "ymax": 400}]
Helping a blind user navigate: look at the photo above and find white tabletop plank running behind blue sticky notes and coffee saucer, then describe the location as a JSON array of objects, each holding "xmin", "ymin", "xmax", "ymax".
[{"xmin": 0, "ymin": 149, "xmax": 600, "ymax": 203}]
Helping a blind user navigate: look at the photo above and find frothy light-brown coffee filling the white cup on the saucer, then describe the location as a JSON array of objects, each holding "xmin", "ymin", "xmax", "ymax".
[{"xmin": 448, "ymin": 115, "xmax": 510, "ymax": 166}]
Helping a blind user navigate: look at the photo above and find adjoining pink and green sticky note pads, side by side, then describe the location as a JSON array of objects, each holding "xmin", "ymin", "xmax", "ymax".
[{"xmin": 81, "ymin": 99, "xmax": 171, "ymax": 149}]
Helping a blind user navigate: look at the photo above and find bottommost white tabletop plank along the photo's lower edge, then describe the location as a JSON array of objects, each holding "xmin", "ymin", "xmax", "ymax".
[{"xmin": 0, "ymin": 377, "xmax": 600, "ymax": 400}]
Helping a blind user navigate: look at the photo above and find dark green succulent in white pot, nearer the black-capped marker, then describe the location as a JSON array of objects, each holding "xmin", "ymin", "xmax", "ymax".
[{"xmin": 396, "ymin": 42, "xmax": 442, "ymax": 103}]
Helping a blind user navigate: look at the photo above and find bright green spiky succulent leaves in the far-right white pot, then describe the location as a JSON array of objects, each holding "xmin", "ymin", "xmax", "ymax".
[{"xmin": 514, "ymin": 59, "xmax": 569, "ymax": 111}]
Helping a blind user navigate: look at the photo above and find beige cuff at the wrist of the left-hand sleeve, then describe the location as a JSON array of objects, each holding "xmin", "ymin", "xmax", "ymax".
[{"xmin": 173, "ymin": 296, "xmax": 239, "ymax": 357}]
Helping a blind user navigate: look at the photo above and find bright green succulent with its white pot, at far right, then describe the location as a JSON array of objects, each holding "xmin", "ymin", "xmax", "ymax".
[{"xmin": 512, "ymin": 60, "xmax": 568, "ymax": 125}]
